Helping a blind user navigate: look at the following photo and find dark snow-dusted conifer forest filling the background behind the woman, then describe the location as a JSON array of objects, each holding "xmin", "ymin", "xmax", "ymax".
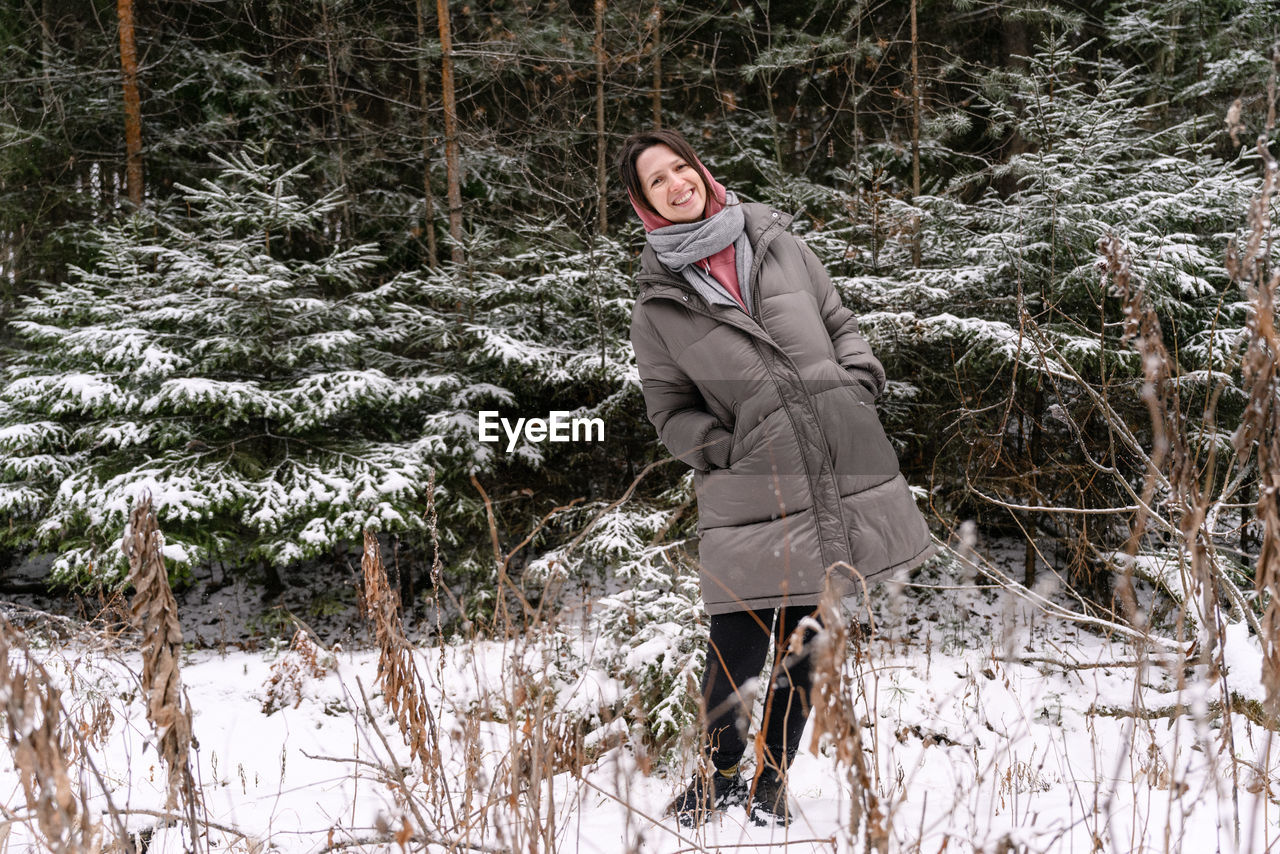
[{"xmin": 0, "ymin": 0, "xmax": 1280, "ymax": 627}]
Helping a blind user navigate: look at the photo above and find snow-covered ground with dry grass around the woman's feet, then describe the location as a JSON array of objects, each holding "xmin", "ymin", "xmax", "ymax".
[{"xmin": 0, "ymin": 547, "xmax": 1280, "ymax": 854}]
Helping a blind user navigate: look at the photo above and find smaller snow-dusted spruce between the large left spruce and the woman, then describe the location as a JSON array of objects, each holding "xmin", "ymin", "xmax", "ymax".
[{"xmin": 406, "ymin": 222, "xmax": 650, "ymax": 609}]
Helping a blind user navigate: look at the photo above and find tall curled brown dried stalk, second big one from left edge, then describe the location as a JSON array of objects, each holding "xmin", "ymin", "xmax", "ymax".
[{"xmin": 120, "ymin": 494, "xmax": 200, "ymax": 848}]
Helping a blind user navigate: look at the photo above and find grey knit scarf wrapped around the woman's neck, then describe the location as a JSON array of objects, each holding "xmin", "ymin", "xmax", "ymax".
[{"xmin": 646, "ymin": 191, "xmax": 754, "ymax": 314}]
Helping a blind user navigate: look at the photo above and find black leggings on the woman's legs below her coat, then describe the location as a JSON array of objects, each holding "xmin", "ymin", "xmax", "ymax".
[{"xmin": 703, "ymin": 607, "xmax": 814, "ymax": 769}]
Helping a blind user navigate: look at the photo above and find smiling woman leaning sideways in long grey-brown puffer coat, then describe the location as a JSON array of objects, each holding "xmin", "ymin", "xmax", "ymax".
[{"xmin": 618, "ymin": 131, "xmax": 932, "ymax": 825}]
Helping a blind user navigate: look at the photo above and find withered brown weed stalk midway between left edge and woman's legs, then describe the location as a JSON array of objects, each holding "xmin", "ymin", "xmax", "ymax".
[{"xmin": 360, "ymin": 531, "xmax": 440, "ymax": 776}]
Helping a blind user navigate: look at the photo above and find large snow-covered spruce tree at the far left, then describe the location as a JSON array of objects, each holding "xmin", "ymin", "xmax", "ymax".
[{"xmin": 0, "ymin": 151, "xmax": 449, "ymax": 583}]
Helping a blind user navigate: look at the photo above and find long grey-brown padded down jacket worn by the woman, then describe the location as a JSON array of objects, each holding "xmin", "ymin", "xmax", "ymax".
[{"xmin": 631, "ymin": 204, "xmax": 932, "ymax": 615}]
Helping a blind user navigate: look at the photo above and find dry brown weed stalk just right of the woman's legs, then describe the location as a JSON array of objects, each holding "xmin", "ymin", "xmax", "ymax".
[{"xmin": 809, "ymin": 592, "xmax": 888, "ymax": 854}]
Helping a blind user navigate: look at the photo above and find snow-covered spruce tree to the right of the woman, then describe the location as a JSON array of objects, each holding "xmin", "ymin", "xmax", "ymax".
[{"xmin": 810, "ymin": 37, "xmax": 1254, "ymax": 594}]
